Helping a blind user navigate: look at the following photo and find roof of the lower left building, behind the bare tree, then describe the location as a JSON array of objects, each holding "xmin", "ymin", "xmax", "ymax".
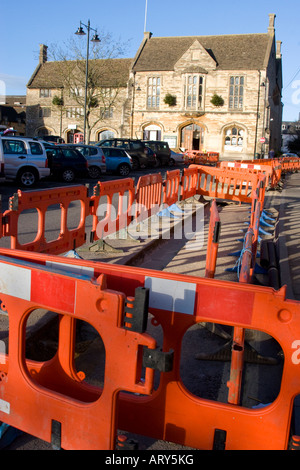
[{"xmin": 27, "ymin": 59, "xmax": 133, "ymax": 88}]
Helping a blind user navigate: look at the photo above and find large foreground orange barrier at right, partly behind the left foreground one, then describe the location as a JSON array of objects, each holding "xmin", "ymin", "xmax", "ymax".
[{"xmin": 0, "ymin": 249, "xmax": 300, "ymax": 450}]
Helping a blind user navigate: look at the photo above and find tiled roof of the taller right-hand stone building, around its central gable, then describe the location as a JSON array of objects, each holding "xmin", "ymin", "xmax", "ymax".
[{"xmin": 134, "ymin": 33, "xmax": 272, "ymax": 72}]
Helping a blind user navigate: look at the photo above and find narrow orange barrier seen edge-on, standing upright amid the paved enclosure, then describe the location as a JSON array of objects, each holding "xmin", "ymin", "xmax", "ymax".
[{"xmin": 205, "ymin": 199, "xmax": 221, "ymax": 278}]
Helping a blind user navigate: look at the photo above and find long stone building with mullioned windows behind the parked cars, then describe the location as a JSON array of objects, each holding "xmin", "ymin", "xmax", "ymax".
[{"xmin": 27, "ymin": 14, "xmax": 282, "ymax": 159}]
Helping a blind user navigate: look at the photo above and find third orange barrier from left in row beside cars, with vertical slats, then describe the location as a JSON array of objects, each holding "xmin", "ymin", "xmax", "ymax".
[{"xmin": 134, "ymin": 173, "xmax": 163, "ymax": 222}]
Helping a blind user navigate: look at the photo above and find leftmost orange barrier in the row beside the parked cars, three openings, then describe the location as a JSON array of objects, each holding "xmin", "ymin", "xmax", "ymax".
[{"xmin": 3, "ymin": 186, "xmax": 89, "ymax": 254}]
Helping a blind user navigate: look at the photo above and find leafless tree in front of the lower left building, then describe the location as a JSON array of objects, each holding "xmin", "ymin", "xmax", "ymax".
[{"xmin": 49, "ymin": 33, "xmax": 130, "ymax": 143}]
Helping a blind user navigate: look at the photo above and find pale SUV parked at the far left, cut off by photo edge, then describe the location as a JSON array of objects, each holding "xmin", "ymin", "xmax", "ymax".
[{"xmin": 0, "ymin": 136, "xmax": 50, "ymax": 188}]
